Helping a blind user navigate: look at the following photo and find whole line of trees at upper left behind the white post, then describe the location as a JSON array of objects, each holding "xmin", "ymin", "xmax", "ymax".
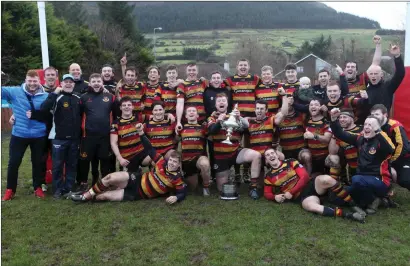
[{"xmin": 1, "ymin": 2, "xmax": 153, "ymax": 84}]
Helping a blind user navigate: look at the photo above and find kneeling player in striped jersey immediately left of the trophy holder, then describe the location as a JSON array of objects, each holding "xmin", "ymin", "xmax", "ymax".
[{"xmin": 179, "ymin": 106, "xmax": 211, "ymax": 196}]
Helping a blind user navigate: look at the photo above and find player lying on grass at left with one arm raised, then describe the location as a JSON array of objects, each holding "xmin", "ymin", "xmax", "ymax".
[{"xmin": 71, "ymin": 124, "xmax": 186, "ymax": 204}]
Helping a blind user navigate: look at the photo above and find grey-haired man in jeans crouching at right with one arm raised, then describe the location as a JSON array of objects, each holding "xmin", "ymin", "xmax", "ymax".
[{"xmin": 330, "ymin": 108, "xmax": 395, "ymax": 214}]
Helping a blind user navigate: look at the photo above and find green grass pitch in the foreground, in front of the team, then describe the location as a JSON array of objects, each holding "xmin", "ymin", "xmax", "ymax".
[{"xmin": 1, "ymin": 137, "xmax": 410, "ymax": 265}]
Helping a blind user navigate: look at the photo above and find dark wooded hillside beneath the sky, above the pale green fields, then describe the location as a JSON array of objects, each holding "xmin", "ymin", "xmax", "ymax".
[{"xmin": 129, "ymin": 2, "xmax": 380, "ymax": 33}]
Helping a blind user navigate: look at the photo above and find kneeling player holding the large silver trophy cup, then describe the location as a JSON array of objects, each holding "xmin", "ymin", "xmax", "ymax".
[{"xmin": 208, "ymin": 93, "xmax": 261, "ymax": 199}]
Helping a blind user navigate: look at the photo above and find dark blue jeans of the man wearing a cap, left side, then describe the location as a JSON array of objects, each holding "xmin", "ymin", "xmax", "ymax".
[{"xmin": 52, "ymin": 139, "xmax": 80, "ymax": 193}]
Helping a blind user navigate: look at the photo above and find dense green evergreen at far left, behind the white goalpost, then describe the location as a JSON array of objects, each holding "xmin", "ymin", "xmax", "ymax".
[{"xmin": 1, "ymin": 2, "xmax": 113, "ymax": 84}]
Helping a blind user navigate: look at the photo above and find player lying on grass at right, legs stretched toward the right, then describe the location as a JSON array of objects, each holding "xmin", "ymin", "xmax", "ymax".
[{"xmin": 264, "ymin": 149, "xmax": 366, "ymax": 222}]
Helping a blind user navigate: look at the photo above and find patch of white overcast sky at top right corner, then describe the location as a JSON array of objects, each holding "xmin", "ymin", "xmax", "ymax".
[{"xmin": 323, "ymin": 2, "xmax": 407, "ymax": 29}]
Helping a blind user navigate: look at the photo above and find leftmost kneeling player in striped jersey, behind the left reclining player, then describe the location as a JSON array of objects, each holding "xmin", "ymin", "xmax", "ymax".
[{"xmin": 110, "ymin": 96, "xmax": 151, "ymax": 172}]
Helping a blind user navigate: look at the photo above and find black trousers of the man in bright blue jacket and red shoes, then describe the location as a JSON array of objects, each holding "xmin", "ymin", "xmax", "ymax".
[{"xmin": 7, "ymin": 135, "xmax": 47, "ymax": 192}]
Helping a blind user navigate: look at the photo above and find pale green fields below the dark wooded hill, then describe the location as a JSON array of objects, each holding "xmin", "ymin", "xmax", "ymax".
[{"xmin": 146, "ymin": 29, "xmax": 397, "ymax": 56}]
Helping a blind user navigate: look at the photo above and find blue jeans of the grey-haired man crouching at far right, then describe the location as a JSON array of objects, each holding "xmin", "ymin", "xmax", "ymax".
[{"xmin": 350, "ymin": 175, "xmax": 389, "ymax": 208}]
